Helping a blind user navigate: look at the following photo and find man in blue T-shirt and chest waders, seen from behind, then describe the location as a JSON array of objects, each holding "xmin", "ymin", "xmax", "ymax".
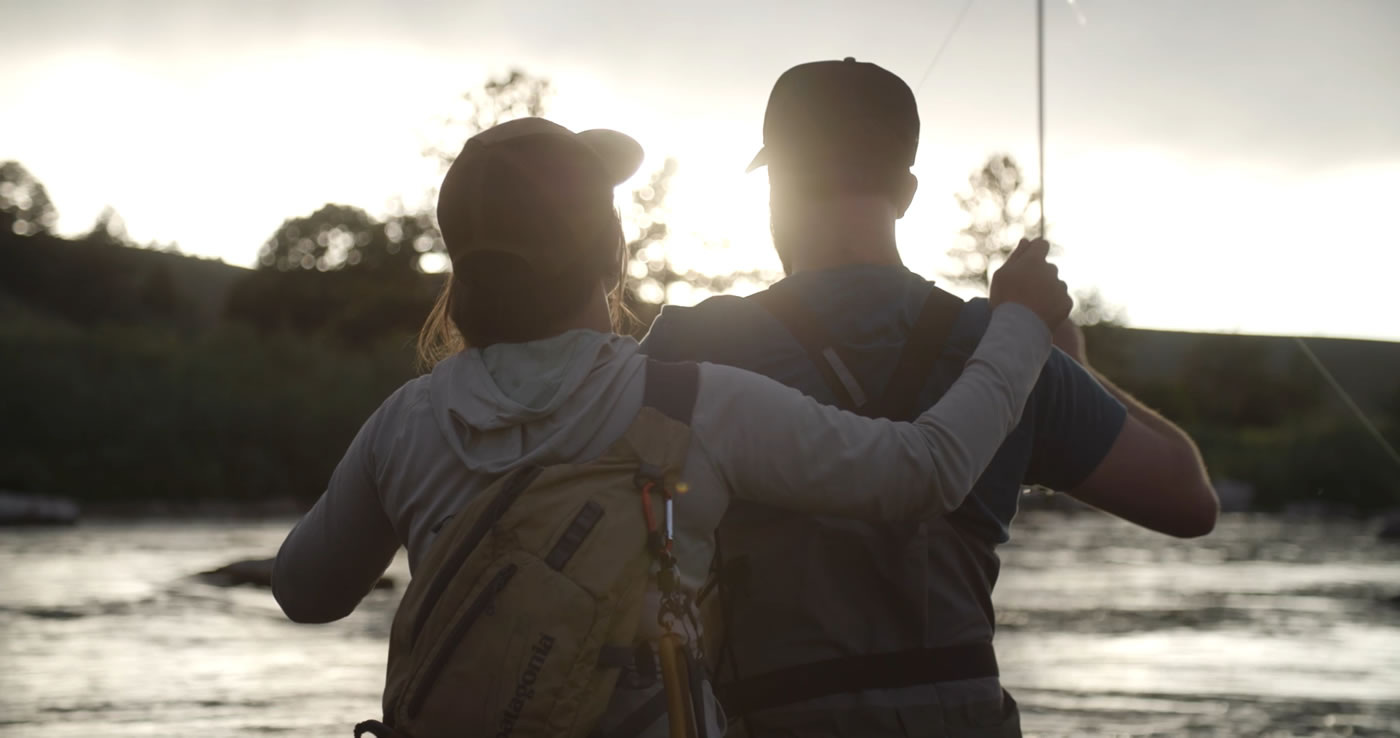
[{"xmin": 641, "ymin": 59, "xmax": 1218, "ymax": 738}]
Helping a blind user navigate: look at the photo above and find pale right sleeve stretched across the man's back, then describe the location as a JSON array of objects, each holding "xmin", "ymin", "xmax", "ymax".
[{"xmin": 692, "ymin": 304, "xmax": 1050, "ymax": 520}]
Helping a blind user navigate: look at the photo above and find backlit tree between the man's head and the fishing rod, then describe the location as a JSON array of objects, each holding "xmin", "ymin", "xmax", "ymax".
[{"xmin": 944, "ymin": 154, "xmax": 1040, "ymax": 291}]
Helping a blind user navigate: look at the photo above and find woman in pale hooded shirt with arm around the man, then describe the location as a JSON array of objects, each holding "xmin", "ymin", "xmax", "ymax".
[{"xmin": 264, "ymin": 118, "xmax": 1070, "ymax": 738}]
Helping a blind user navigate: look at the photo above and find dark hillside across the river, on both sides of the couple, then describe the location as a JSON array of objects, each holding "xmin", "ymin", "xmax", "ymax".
[{"xmin": 0, "ymin": 218, "xmax": 1400, "ymax": 510}]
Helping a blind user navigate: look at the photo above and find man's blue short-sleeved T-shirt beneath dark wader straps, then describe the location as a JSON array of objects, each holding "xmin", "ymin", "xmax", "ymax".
[{"xmin": 641, "ymin": 265, "xmax": 1126, "ymax": 543}]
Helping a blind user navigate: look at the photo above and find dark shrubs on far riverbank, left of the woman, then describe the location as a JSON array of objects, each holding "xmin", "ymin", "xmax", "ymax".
[{"xmin": 0, "ymin": 309, "xmax": 413, "ymax": 501}]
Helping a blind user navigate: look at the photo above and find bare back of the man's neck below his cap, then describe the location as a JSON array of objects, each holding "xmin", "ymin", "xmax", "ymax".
[{"xmin": 773, "ymin": 197, "xmax": 904, "ymax": 274}]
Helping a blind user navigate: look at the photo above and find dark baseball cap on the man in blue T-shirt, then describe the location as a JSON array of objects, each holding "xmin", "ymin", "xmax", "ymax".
[{"xmin": 748, "ymin": 57, "xmax": 918, "ymax": 172}]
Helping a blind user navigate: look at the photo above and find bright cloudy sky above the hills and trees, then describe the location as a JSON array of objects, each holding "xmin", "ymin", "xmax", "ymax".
[{"xmin": 0, "ymin": 0, "xmax": 1400, "ymax": 340}]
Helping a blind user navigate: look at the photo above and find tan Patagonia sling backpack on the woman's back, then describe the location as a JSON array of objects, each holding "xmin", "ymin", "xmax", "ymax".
[{"xmin": 356, "ymin": 360, "xmax": 697, "ymax": 738}]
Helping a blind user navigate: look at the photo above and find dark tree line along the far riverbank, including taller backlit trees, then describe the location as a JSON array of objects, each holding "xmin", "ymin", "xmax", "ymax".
[{"xmin": 0, "ymin": 71, "xmax": 1400, "ymax": 508}]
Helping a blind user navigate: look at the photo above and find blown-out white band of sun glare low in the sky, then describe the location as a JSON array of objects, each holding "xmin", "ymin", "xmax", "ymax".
[{"xmin": 10, "ymin": 45, "xmax": 1400, "ymax": 335}]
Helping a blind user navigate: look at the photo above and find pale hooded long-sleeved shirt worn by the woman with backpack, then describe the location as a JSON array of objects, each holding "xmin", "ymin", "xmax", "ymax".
[{"xmin": 273, "ymin": 305, "xmax": 1050, "ymax": 622}]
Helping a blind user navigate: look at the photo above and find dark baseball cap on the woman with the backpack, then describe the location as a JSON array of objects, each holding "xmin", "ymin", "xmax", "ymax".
[{"xmin": 437, "ymin": 118, "xmax": 643, "ymax": 274}]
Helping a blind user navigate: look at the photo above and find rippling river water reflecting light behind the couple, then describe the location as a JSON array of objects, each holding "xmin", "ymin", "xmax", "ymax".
[{"xmin": 0, "ymin": 513, "xmax": 1400, "ymax": 738}]
